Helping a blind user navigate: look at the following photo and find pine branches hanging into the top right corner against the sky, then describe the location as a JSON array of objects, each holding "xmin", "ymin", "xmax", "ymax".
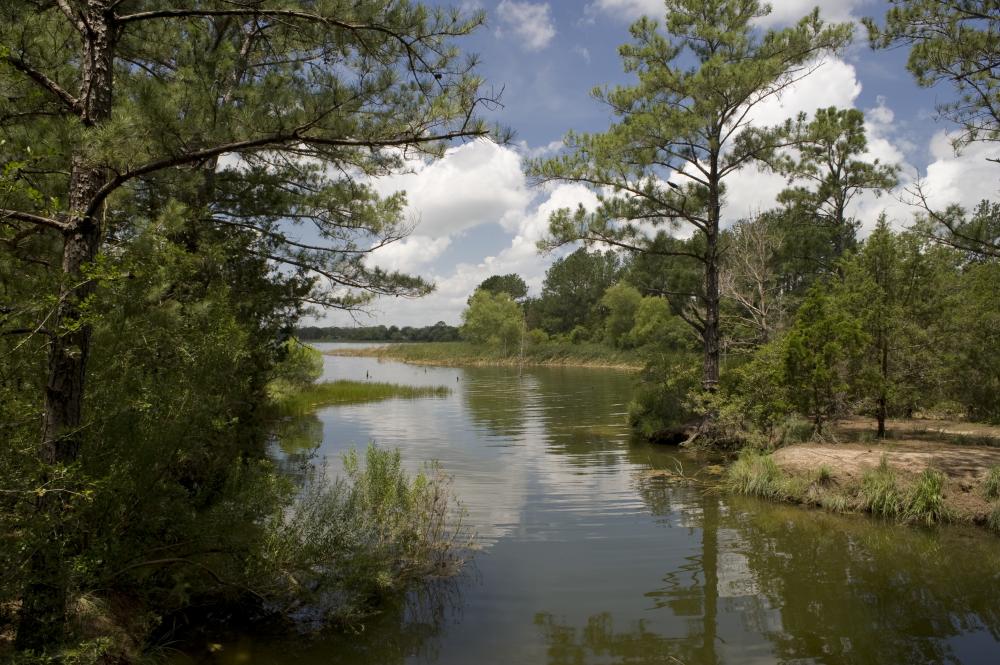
[{"xmin": 864, "ymin": 0, "xmax": 1000, "ymax": 147}]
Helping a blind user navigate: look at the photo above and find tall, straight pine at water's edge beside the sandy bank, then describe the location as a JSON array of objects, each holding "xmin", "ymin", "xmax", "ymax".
[{"xmin": 532, "ymin": 0, "xmax": 851, "ymax": 390}]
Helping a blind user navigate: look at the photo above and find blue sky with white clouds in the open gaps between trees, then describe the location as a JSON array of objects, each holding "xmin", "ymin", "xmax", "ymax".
[{"xmin": 319, "ymin": 0, "xmax": 998, "ymax": 326}]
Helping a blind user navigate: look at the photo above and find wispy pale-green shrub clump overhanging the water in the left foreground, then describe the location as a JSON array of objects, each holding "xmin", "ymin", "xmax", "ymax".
[{"xmin": 260, "ymin": 445, "xmax": 472, "ymax": 625}]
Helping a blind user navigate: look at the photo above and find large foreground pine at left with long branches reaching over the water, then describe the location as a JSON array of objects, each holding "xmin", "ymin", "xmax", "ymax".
[{"xmin": 0, "ymin": 0, "xmax": 496, "ymax": 649}]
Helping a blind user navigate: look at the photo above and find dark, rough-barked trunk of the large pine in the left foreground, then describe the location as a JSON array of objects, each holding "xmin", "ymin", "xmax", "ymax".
[{"xmin": 16, "ymin": 0, "xmax": 114, "ymax": 652}]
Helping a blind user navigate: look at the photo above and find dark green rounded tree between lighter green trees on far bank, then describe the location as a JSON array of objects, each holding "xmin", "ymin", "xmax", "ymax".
[{"xmin": 537, "ymin": 247, "xmax": 621, "ymax": 334}]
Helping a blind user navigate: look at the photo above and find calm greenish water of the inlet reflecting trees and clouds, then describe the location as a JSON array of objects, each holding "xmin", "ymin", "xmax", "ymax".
[{"xmin": 214, "ymin": 345, "xmax": 1000, "ymax": 665}]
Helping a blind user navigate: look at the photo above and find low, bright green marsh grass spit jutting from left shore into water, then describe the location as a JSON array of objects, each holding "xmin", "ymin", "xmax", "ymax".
[{"xmin": 268, "ymin": 380, "xmax": 451, "ymax": 416}]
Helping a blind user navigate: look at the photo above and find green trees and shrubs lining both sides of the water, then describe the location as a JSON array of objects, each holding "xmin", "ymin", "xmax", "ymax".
[{"xmin": 0, "ymin": 0, "xmax": 1000, "ymax": 664}]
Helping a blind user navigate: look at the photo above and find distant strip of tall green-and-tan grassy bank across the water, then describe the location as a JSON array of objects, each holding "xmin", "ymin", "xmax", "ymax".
[{"xmin": 324, "ymin": 342, "xmax": 643, "ymax": 372}]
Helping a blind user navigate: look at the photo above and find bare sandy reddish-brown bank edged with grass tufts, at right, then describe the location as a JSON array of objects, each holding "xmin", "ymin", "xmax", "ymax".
[{"xmin": 724, "ymin": 419, "xmax": 1000, "ymax": 532}]
